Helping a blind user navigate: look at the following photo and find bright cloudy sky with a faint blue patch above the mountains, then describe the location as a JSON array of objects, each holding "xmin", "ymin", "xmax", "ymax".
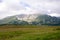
[{"xmin": 0, "ymin": 0, "xmax": 60, "ymax": 19}]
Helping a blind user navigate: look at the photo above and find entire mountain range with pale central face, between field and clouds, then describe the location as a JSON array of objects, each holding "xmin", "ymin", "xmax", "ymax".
[{"xmin": 0, "ymin": 14, "xmax": 60, "ymax": 25}]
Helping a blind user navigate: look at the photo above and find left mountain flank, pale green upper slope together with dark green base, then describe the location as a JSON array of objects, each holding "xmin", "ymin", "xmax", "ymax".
[{"xmin": 0, "ymin": 16, "xmax": 28, "ymax": 25}]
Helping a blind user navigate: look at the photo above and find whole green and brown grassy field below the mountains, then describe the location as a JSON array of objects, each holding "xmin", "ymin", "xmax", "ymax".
[{"xmin": 0, "ymin": 25, "xmax": 60, "ymax": 40}]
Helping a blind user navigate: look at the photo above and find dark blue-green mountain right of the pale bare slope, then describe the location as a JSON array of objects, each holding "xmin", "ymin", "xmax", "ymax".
[{"xmin": 31, "ymin": 15, "xmax": 60, "ymax": 25}]
